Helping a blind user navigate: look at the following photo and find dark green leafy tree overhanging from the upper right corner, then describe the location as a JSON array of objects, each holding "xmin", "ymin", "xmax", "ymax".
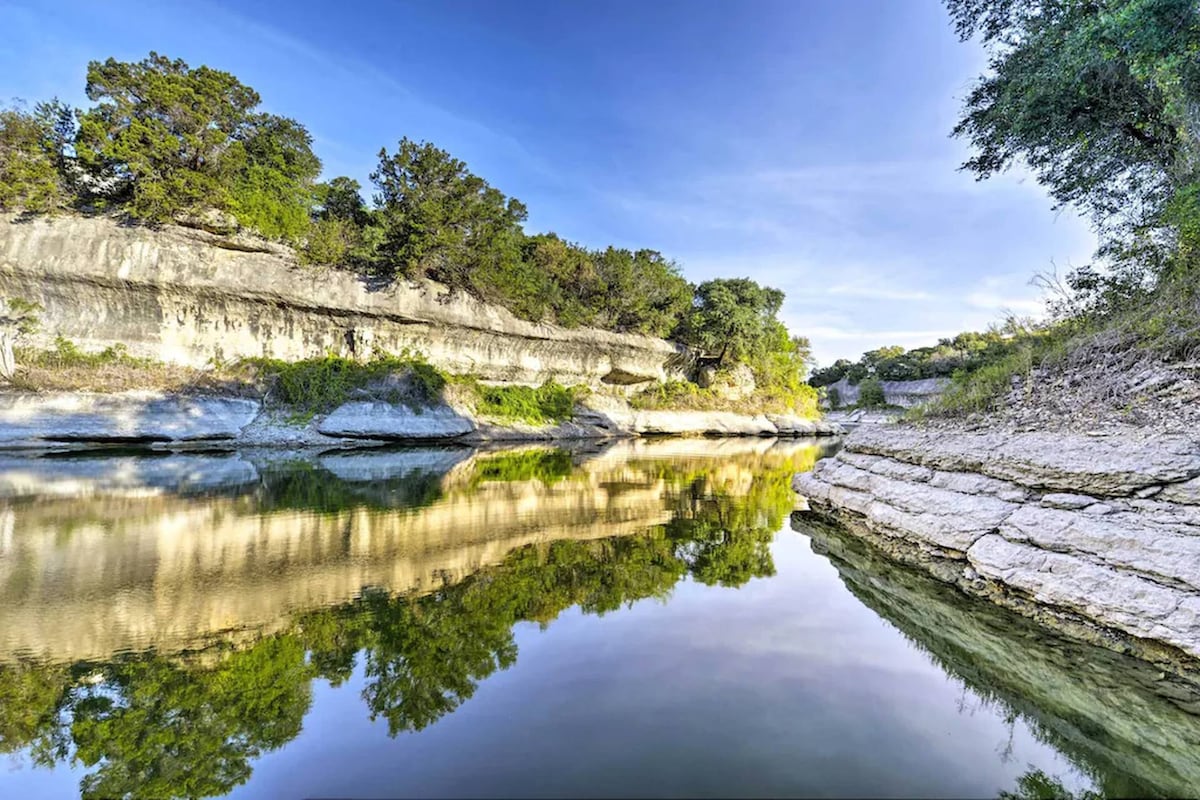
[{"xmin": 947, "ymin": 0, "xmax": 1200, "ymax": 283}]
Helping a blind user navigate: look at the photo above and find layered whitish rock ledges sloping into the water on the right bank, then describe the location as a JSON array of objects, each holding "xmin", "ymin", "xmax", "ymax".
[{"xmin": 793, "ymin": 426, "xmax": 1200, "ymax": 657}]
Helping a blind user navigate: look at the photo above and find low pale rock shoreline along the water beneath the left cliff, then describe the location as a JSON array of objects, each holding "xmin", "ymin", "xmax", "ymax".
[{"xmin": 0, "ymin": 392, "xmax": 841, "ymax": 450}]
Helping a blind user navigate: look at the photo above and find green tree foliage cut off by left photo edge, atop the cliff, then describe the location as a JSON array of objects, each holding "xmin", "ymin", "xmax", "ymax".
[{"xmin": 0, "ymin": 101, "xmax": 70, "ymax": 213}]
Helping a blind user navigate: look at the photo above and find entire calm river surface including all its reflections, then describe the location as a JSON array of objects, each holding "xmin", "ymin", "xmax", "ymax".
[{"xmin": 0, "ymin": 440, "xmax": 1200, "ymax": 798}]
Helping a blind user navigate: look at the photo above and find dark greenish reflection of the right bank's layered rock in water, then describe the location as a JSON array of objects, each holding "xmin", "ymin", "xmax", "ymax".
[{"xmin": 792, "ymin": 513, "xmax": 1200, "ymax": 800}]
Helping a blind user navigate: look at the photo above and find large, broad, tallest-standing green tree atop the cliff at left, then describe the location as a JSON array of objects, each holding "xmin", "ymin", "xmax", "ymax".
[{"xmin": 74, "ymin": 53, "xmax": 320, "ymax": 227}]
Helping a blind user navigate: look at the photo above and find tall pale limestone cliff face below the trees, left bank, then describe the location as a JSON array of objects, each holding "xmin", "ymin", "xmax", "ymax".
[{"xmin": 0, "ymin": 217, "xmax": 689, "ymax": 386}]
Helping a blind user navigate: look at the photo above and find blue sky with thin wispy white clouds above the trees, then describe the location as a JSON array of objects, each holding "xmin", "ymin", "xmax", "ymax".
[{"xmin": 0, "ymin": 0, "xmax": 1094, "ymax": 363}]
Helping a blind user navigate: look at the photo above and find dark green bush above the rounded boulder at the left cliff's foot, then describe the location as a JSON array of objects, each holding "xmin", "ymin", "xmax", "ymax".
[{"xmin": 251, "ymin": 354, "xmax": 445, "ymax": 416}]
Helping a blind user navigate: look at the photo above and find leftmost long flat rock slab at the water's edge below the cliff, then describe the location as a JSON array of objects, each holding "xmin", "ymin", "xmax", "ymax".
[{"xmin": 0, "ymin": 392, "xmax": 259, "ymax": 444}]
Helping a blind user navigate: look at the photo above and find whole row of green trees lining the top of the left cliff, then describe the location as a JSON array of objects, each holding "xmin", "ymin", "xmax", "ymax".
[{"xmin": 0, "ymin": 53, "xmax": 809, "ymax": 393}]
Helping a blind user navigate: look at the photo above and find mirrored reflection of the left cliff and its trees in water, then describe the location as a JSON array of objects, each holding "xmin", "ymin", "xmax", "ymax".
[{"xmin": 0, "ymin": 440, "xmax": 818, "ymax": 798}]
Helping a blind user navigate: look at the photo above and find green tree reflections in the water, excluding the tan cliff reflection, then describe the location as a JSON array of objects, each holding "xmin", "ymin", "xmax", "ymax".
[{"xmin": 0, "ymin": 453, "xmax": 794, "ymax": 798}]
